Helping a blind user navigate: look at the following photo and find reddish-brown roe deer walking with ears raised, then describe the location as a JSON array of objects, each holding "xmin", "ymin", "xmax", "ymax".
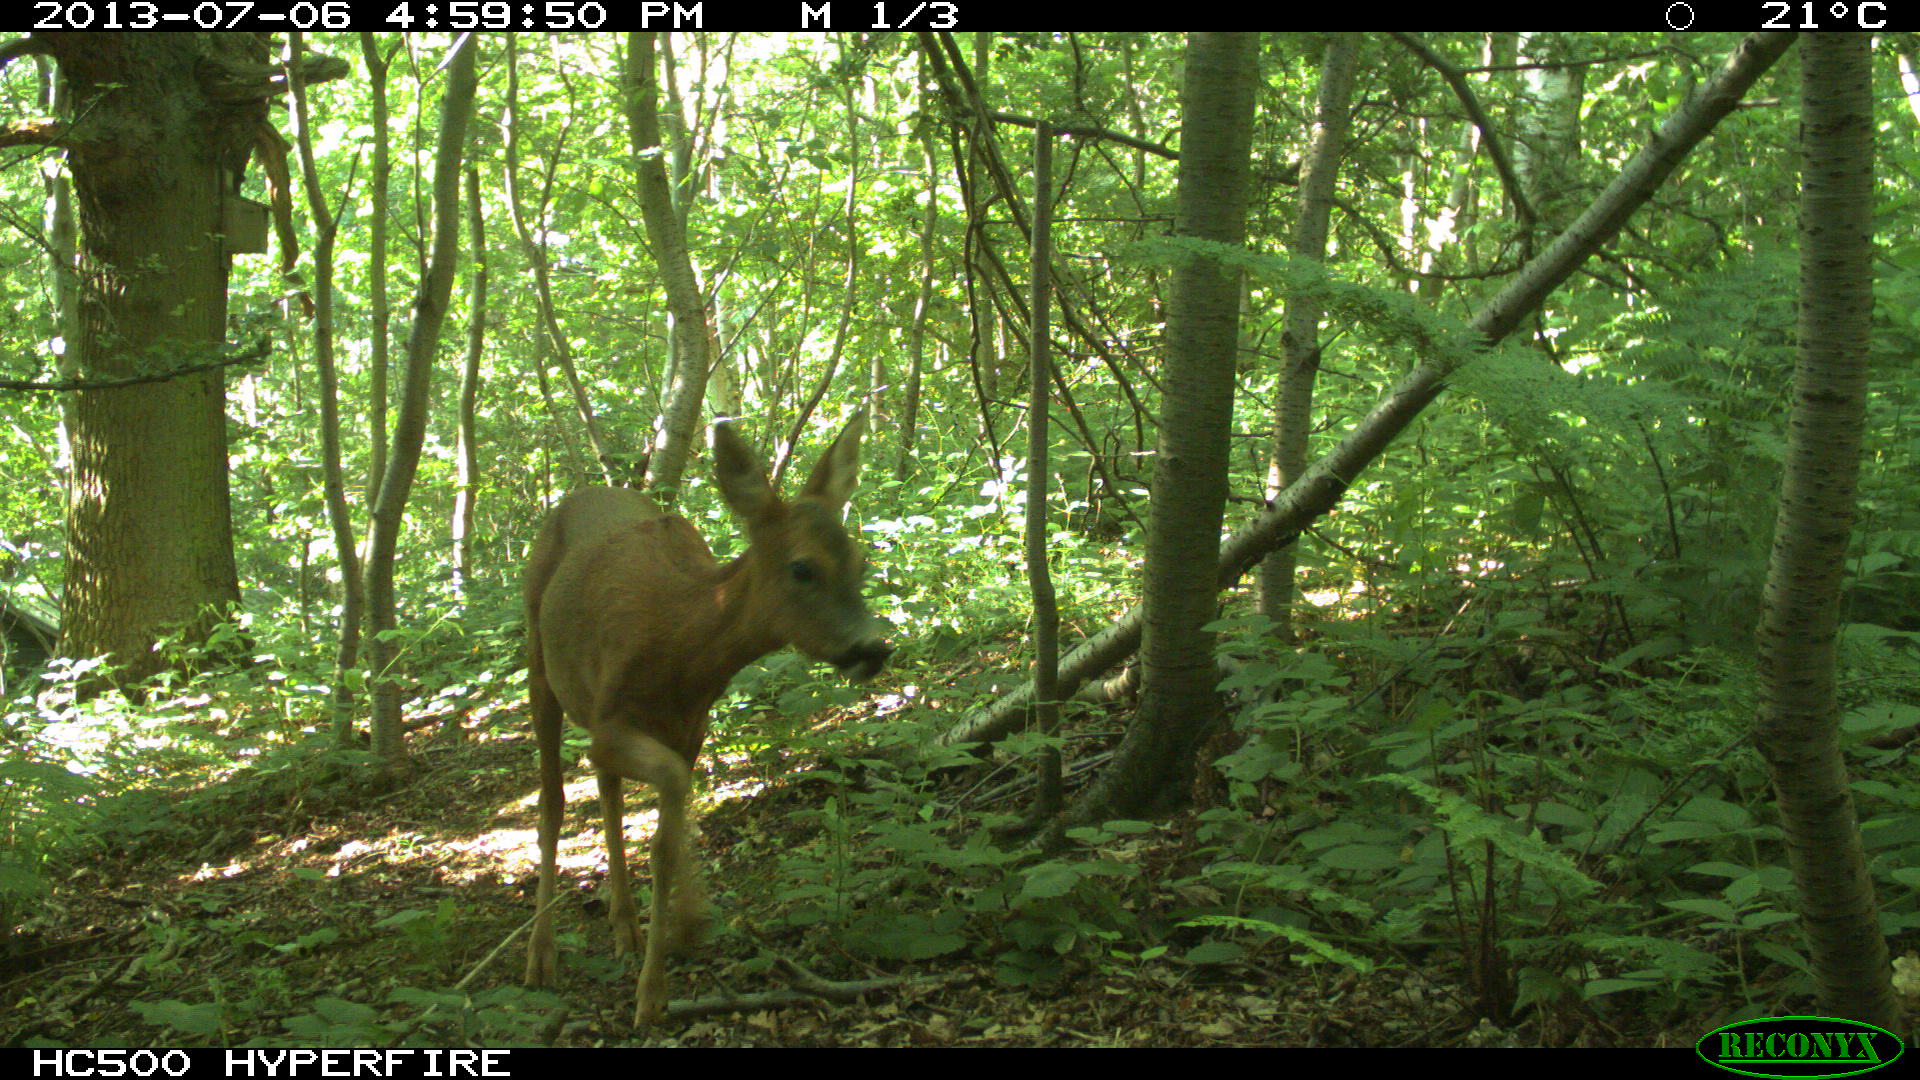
[{"xmin": 524, "ymin": 413, "xmax": 893, "ymax": 1024}]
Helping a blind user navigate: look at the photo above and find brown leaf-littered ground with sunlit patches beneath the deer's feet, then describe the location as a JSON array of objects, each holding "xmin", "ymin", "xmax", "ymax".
[{"xmin": 0, "ymin": 699, "xmax": 1692, "ymax": 1047}]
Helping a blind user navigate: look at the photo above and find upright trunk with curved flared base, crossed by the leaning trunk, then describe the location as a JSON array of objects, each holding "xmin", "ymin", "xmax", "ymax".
[{"xmin": 1071, "ymin": 33, "xmax": 1260, "ymax": 821}]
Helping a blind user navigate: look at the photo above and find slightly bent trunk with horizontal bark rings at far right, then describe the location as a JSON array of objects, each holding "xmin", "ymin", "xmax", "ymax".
[{"xmin": 1755, "ymin": 35, "xmax": 1901, "ymax": 1030}]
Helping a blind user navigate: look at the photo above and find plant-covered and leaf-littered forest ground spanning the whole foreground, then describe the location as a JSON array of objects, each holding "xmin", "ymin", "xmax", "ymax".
[{"xmin": 11, "ymin": 557, "xmax": 1912, "ymax": 1045}]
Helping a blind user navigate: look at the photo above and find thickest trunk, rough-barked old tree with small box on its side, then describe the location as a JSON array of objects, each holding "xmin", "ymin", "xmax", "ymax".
[{"xmin": 42, "ymin": 33, "xmax": 269, "ymax": 680}]
